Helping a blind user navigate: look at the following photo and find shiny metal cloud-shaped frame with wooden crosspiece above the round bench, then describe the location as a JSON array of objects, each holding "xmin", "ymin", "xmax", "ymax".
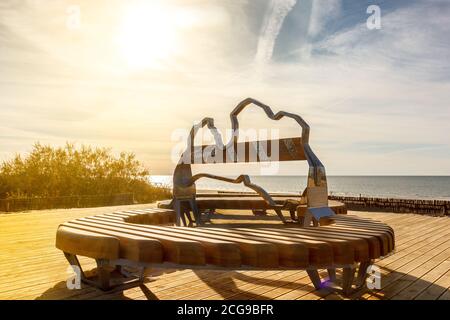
[{"xmin": 172, "ymin": 98, "xmax": 334, "ymax": 226}]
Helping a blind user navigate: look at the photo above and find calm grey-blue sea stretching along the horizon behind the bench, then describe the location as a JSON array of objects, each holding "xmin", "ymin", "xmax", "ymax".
[{"xmin": 150, "ymin": 176, "xmax": 450, "ymax": 200}]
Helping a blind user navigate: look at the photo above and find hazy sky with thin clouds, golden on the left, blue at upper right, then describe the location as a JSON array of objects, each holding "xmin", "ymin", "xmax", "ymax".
[{"xmin": 0, "ymin": 0, "xmax": 450, "ymax": 175}]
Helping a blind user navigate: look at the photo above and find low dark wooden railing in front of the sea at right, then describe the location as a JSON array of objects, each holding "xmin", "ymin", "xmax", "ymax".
[{"xmin": 328, "ymin": 196, "xmax": 450, "ymax": 216}]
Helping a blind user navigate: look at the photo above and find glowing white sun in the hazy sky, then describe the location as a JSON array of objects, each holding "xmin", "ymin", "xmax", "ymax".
[{"xmin": 117, "ymin": 1, "xmax": 179, "ymax": 69}]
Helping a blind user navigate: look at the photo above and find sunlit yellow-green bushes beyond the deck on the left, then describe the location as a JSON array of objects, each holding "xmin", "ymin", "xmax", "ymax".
[{"xmin": 0, "ymin": 143, "xmax": 170, "ymax": 202}]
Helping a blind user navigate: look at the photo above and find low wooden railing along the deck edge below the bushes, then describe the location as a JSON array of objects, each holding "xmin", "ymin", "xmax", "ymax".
[{"xmin": 0, "ymin": 193, "xmax": 135, "ymax": 212}]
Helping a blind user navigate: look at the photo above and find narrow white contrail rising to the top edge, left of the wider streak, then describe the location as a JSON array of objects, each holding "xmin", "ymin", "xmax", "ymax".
[{"xmin": 255, "ymin": 0, "xmax": 297, "ymax": 65}]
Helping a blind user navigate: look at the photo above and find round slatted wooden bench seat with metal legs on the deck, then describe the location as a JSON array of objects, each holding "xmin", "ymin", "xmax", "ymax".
[{"xmin": 56, "ymin": 209, "xmax": 395, "ymax": 293}]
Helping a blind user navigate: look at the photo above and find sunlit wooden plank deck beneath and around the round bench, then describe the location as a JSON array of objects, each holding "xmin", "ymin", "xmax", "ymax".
[{"xmin": 0, "ymin": 205, "xmax": 450, "ymax": 300}]
